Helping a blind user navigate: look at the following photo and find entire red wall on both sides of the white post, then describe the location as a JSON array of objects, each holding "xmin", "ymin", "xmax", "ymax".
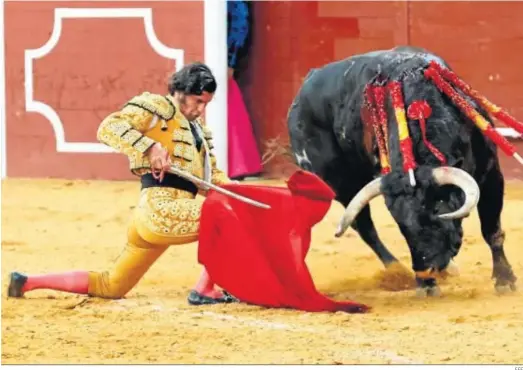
[{"xmin": 5, "ymin": 1, "xmax": 523, "ymax": 179}]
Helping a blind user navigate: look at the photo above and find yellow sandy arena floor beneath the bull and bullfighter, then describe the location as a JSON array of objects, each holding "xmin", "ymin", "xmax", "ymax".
[{"xmin": 2, "ymin": 179, "xmax": 523, "ymax": 364}]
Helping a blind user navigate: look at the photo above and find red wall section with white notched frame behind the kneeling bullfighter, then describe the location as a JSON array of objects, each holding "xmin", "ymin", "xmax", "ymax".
[{"xmin": 5, "ymin": 1, "xmax": 203, "ymax": 179}]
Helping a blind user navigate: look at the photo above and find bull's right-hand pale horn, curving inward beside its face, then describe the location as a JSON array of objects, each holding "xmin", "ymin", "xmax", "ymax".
[{"xmin": 432, "ymin": 167, "xmax": 480, "ymax": 220}]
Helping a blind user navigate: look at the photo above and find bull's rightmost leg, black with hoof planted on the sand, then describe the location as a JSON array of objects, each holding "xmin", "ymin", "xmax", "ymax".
[{"xmin": 478, "ymin": 166, "xmax": 517, "ymax": 293}]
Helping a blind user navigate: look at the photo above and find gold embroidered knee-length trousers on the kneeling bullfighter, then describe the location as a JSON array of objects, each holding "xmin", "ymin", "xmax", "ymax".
[{"xmin": 89, "ymin": 187, "xmax": 203, "ymax": 299}]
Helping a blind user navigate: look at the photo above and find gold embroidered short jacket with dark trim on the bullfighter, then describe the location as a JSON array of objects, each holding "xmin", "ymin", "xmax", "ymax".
[{"xmin": 97, "ymin": 92, "xmax": 230, "ymax": 185}]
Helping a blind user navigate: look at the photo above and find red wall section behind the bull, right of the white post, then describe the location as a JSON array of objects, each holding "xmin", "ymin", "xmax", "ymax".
[{"xmin": 242, "ymin": 1, "xmax": 523, "ymax": 178}]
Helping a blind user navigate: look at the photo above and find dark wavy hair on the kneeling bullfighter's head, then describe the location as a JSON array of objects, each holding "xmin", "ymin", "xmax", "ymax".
[{"xmin": 168, "ymin": 62, "xmax": 217, "ymax": 95}]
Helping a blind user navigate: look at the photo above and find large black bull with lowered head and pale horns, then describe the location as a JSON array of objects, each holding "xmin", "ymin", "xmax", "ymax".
[{"xmin": 288, "ymin": 47, "xmax": 516, "ymax": 295}]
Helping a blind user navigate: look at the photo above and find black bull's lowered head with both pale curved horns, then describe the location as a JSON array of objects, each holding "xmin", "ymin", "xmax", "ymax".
[{"xmin": 336, "ymin": 163, "xmax": 479, "ymax": 278}]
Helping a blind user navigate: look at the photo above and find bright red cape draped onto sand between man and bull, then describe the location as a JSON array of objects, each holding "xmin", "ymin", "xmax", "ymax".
[{"xmin": 198, "ymin": 170, "xmax": 369, "ymax": 312}]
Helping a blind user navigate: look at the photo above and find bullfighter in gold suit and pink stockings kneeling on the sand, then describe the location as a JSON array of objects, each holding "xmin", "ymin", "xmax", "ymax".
[{"xmin": 8, "ymin": 63, "xmax": 241, "ymax": 305}]
